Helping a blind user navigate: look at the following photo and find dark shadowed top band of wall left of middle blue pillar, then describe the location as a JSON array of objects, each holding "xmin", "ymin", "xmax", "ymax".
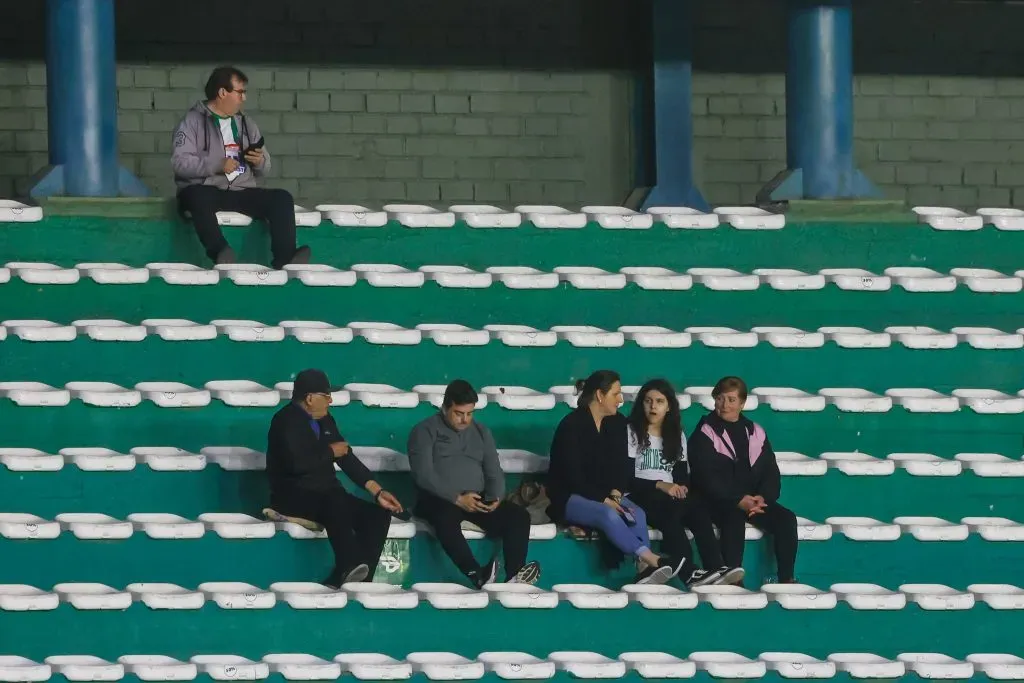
[{"xmin": 0, "ymin": 0, "xmax": 650, "ymax": 70}]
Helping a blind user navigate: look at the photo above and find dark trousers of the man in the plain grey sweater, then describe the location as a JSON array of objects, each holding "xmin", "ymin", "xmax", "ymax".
[{"xmin": 416, "ymin": 489, "xmax": 529, "ymax": 580}]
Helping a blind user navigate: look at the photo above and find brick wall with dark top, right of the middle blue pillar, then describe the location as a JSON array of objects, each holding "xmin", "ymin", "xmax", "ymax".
[{"xmin": 693, "ymin": 0, "xmax": 1024, "ymax": 208}]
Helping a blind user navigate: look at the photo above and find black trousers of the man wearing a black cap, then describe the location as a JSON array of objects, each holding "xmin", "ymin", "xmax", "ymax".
[{"xmin": 270, "ymin": 486, "xmax": 391, "ymax": 581}]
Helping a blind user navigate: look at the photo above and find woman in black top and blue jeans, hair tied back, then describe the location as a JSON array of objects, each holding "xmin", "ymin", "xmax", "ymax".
[{"xmin": 548, "ymin": 370, "xmax": 683, "ymax": 584}]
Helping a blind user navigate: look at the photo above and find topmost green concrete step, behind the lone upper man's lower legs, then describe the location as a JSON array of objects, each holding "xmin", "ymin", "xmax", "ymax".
[{"xmin": 0, "ymin": 217, "xmax": 1022, "ymax": 271}]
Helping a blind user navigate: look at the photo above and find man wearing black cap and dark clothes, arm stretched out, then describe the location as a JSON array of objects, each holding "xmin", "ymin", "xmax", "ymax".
[{"xmin": 265, "ymin": 370, "xmax": 402, "ymax": 588}]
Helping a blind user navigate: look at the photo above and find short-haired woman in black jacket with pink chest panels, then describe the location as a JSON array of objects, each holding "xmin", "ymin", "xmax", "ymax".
[{"xmin": 689, "ymin": 377, "xmax": 797, "ymax": 584}]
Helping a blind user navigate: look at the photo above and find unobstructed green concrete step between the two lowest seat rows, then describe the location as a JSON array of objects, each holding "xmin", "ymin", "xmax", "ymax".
[{"xmin": 0, "ymin": 605, "xmax": 1021, "ymax": 663}]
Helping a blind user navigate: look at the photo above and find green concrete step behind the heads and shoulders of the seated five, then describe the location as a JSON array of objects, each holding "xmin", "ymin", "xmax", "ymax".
[{"xmin": 0, "ymin": 403, "xmax": 1024, "ymax": 458}]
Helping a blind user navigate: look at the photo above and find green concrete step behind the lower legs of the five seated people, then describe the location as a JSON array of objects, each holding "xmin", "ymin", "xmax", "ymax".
[{"xmin": 0, "ymin": 531, "xmax": 1011, "ymax": 589}]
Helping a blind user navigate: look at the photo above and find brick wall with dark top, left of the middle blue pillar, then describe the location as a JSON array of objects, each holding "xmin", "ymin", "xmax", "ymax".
[{"xmin": 0, "ymin": 0, "xmax": 648, "ymax": 205}]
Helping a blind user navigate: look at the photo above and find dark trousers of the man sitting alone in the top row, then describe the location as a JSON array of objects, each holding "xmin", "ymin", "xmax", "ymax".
[{"xmin": 178, "ymin": 185, "xmax": 295, "ymax": 268}]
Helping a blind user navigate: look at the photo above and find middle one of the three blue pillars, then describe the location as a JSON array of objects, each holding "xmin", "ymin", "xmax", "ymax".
[{"xmin": 638, "ymin": 0, "xmax": 708, "ymax": 211}]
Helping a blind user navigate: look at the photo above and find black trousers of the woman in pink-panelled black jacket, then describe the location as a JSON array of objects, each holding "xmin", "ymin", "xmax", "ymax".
[{"xmin": 711, "ymin": 503, "xmax": 797, "ymax": 583}]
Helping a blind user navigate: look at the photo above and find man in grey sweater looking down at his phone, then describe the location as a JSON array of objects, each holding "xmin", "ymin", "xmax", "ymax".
[{"xmin": 409, "ymin": 380, "xmax": 541, "ymax": 589}]
